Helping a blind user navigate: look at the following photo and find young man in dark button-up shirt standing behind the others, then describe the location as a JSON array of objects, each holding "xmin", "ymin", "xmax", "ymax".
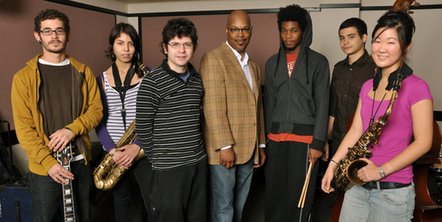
[{"xmin": 323, "ymin": 18, "xmax": 376, "ymax": 161}]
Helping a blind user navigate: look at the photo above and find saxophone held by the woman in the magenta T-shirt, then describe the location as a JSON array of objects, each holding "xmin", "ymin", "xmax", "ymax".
[{"xmin": 334, "ymin": 80, "xmax": 401, "ymax": 191}]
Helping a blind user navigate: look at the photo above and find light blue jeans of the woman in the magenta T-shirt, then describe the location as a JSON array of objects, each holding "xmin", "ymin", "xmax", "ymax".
[{"xmin": 339, "ymin": 183, "xmax": 416, "ymax": 222}]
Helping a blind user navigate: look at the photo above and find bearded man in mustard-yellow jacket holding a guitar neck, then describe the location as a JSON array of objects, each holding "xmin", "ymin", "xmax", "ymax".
[{"xmin": 11, "ymin": 9, "xmax": 102, "ymax": 222}]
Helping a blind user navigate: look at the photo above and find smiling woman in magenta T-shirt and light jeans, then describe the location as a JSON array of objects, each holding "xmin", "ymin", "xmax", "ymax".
[{"xmin": 322, "ymin": 11, "xmax": 433, "ymax": 222}]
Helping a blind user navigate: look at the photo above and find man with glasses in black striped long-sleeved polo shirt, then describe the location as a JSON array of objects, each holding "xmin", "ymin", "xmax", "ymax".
[{"xmin": 136, "ymin": 18, "xmax": 208, "ymax": 222}]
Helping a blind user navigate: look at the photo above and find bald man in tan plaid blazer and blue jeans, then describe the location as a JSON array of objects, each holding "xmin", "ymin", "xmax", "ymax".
[{"xmin": 200, "ymin": 11, "xmax": 266, "ymax": 222}]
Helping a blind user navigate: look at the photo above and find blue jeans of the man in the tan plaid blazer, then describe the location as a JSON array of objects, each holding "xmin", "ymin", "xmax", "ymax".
[{"xmin": 209, "ymin": 158, "xmax": 253, "ymax": 222}]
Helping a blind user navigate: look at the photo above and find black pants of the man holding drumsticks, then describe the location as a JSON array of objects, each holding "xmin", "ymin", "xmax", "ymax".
[{"xmin": 264, "ymin": 140, "xmax": 319, "ymax": 222}]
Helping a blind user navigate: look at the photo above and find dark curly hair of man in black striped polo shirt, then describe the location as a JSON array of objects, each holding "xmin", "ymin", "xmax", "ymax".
[{"xmin": 160, "ymin": 18, "xmax": 198, "ymax": 57}]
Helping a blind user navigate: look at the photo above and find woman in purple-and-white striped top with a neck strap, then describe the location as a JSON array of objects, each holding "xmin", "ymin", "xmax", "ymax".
[{"xmin": 95, "ymin": 23, "xmax": 151, "ymax": 222}]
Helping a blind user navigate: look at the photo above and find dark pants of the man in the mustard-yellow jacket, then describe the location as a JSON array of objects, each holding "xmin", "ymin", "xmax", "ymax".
[{"xmin": 29, "ymin": 160, "xmax": 93, "ymax": 222}]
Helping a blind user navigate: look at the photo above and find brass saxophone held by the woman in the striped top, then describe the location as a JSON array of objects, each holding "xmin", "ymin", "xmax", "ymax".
[{"xmin": 94, "ymin": 119, "xmax": 146, "ymax": 191}]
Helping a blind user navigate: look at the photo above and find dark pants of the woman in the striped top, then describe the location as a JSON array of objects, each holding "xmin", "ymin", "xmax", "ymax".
[{"xmin": 112, "ymin": 155, "xmax": 151, "ymax": 222}]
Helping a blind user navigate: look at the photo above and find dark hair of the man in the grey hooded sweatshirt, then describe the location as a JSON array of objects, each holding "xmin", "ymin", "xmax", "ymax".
[{"xmin": 276, "ymin": 4, "xmax": 308, "ymax": 32}]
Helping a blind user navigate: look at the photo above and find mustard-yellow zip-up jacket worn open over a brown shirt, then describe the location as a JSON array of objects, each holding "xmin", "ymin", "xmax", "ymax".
[{"xmin": 11, "ymin": 55, "xmax": 103, "ymax": 176}]
